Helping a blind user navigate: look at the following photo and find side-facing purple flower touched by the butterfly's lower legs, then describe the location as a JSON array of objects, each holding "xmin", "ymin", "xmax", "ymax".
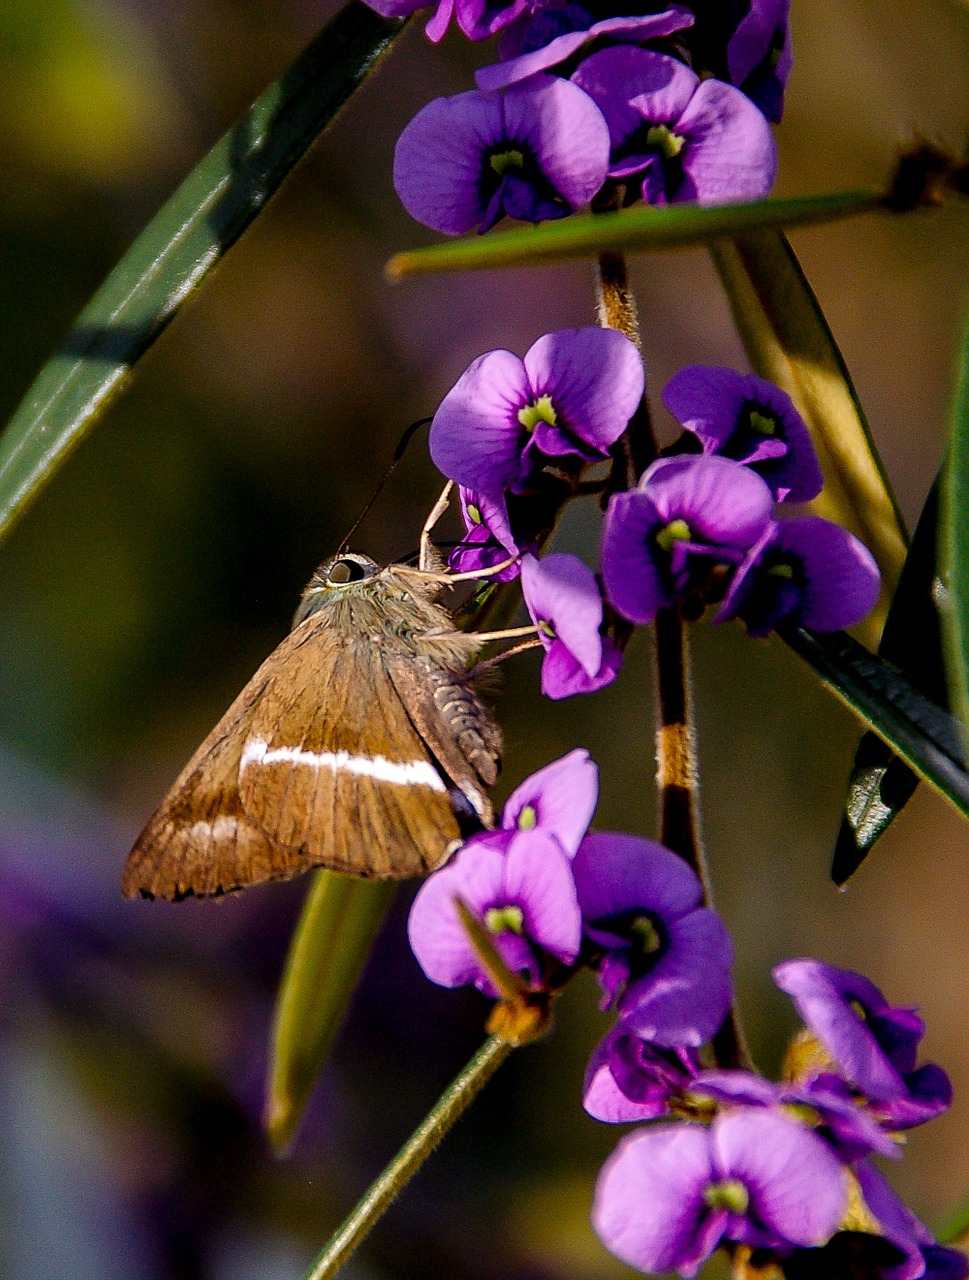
[{"xmin": 521, "ymin": 552, "xmax": 622, "ymax": 698}]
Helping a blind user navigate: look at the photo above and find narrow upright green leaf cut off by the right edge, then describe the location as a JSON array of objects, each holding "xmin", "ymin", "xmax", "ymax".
[{"xmin": 940, "ymin": 303, "xmax": 969, "ymax": 724}]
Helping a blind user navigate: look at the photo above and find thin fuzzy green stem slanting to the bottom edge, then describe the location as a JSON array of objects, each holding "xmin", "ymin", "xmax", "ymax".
[{"xmin": 305, "ymin": 1036, "xmax": 513, "ymax": 1280}]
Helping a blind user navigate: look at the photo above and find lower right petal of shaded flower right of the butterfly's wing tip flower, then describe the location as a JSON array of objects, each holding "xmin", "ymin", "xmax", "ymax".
[{"xmin": 618, "ymin": 908, "xmax": 733, "ymax": 1047}]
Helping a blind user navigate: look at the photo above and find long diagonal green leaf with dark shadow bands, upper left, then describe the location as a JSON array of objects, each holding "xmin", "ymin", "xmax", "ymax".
[{"xmin": 0, "ymin": 4, "xmax": 403, "ymax": 550}]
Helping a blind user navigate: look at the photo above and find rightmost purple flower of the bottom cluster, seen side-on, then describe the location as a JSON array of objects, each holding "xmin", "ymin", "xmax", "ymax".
[{"xmin": 773, "ymin": 959, "xmax": 952, "ymax": 1129}]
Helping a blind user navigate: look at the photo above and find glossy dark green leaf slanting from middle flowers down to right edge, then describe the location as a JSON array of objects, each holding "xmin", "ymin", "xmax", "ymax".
[{"xmin": 778, "ymin": 627, "xmax": 969, "ymax": 817}]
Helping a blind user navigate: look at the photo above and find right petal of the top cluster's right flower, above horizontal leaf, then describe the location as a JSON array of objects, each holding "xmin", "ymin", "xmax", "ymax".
[{"xmin": 672, "ymin": 79, "xmax": 777, "ymax": 204}]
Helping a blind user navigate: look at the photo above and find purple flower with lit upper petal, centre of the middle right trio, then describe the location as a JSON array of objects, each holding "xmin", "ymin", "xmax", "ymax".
[{"xmin": 602, "ymin": 454, "xmax": 773, "ymax": 625}]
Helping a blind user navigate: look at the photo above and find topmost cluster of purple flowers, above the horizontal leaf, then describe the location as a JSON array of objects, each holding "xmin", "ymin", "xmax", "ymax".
[{"xmin": 381, "ymin": 0, "xmax": 791, "ymax": 236}]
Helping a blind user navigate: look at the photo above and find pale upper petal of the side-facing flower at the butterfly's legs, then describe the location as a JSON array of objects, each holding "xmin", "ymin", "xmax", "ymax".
[{"xmin": 521, "ymin": 552, "xmax": 603, "ymax": 676}]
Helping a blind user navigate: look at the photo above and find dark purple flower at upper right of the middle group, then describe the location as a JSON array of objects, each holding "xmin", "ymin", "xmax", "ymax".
[{"xmin": 663, "ymin": 365, "xmax": 824, "ymax": 502}]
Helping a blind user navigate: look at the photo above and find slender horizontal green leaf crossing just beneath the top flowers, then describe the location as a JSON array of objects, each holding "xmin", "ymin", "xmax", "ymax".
[{"xmin": 387, "ymin": 191, "xmax": 882, "ymax": 280}]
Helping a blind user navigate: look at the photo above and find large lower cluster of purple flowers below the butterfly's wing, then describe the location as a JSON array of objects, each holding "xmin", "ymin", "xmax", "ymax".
[{"xmin": 408, "ymin": 750, "xmax": 969, "ymax": 1280}]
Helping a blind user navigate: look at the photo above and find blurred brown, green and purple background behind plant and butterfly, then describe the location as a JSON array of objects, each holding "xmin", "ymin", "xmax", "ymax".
[{"xmin": 0, "ymin": 0, "xmax": 969, "ymax": 1280}]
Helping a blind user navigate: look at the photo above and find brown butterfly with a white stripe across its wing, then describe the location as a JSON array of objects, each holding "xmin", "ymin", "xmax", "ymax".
[{"xmin": 122, "ymin": 553, "xmax": 501, "ymax": 900}]
